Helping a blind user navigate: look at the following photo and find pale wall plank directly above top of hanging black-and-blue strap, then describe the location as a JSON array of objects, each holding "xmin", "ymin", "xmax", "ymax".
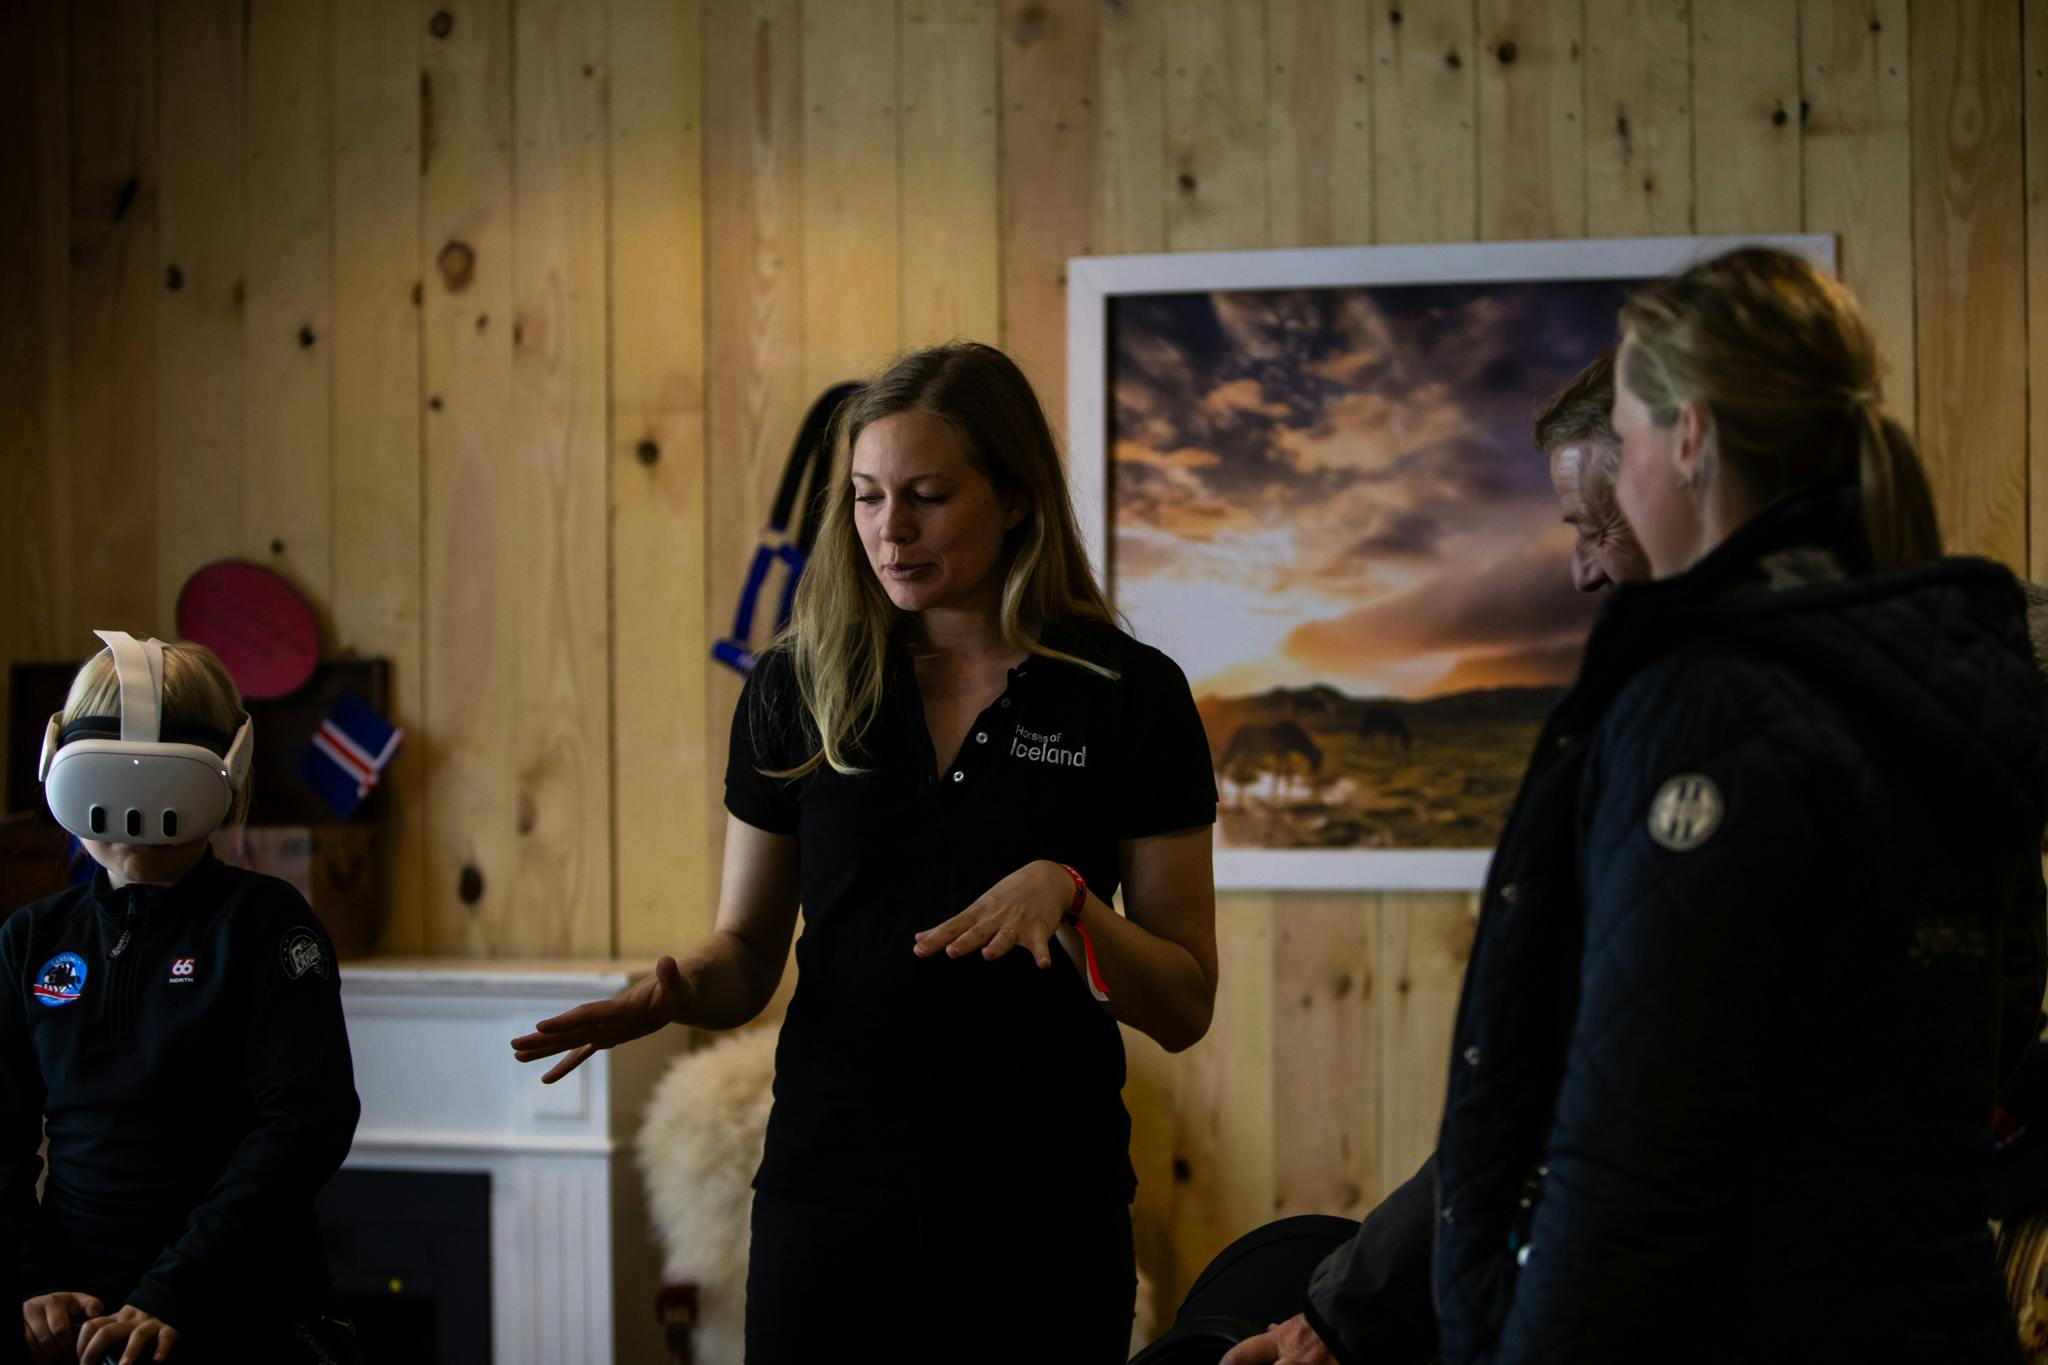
[{"xmin": 798, "ymin": 0, "xmax": 903, "ymax": 388}]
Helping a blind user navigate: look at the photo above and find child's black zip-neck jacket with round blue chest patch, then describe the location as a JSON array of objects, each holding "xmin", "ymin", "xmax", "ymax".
[{"xmin": 0, "ymin": 851, "xmax": 360, "ymax": 1332}]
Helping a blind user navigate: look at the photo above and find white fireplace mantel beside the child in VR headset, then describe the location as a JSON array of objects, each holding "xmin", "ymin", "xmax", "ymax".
[{"xmin": 342, "ymin": 958, "xmax": 684, "ymax": 1365}]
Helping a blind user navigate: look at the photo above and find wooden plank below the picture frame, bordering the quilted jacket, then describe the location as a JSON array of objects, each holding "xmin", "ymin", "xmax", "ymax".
[{"xmin": 1378, "ymin": 894, "xmax": 1479, "ymax": 1193}]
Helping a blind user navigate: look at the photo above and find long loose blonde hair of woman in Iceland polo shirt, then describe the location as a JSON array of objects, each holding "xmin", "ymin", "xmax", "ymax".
[{"xmin": 774, "ymin": 342, "xmax": 1114, "ymax": 778}]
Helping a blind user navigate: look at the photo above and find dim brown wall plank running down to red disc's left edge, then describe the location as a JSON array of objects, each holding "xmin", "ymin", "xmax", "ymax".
[{"xmin": 156, "ymin": 0, "xmax": 248, "ymax": 624}]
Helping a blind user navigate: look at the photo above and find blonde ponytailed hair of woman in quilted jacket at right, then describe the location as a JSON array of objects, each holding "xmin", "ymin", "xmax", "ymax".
[{"xmin": 1622, "ymin": 248, "xmax": 1942, "ymax": 569}]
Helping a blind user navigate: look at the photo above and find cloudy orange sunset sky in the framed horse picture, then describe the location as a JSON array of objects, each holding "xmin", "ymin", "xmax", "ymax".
[{"xmin": 1110, "ymin": 280, "xmax": 1628, "ymax": 698}]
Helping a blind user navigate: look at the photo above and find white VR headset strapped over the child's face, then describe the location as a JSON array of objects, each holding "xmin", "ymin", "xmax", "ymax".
[{"xmin": 37, "ymin": 630, "xmax": 254, "ymax": 843}]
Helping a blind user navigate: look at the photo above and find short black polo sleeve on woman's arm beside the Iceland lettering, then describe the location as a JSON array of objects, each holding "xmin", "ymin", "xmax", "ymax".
[{"xmin": 1114, "ymin": 645, "xmax": 1217, "ymax": 839}]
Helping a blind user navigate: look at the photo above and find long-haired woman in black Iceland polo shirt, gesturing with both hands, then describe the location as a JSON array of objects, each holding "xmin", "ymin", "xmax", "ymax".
[{"xmin": 514, "ymin": 344, "xmax": 1217, "ymax": 1365}]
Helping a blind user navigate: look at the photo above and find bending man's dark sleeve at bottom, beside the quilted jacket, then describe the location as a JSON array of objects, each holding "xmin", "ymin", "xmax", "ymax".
[{"xmin": 1303, "ymin": 1152, "xmax": 1438, "ymax": 1365}]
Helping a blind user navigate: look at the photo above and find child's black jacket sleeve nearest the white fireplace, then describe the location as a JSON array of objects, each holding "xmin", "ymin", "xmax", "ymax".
[{"xmin": 129, "ymin": 884, "xmax": 360, "ymax": 1326}]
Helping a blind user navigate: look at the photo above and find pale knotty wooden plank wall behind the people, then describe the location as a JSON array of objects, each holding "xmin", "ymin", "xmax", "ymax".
[{"xmin": 0, "ymin": 0, "xmax": 2048, "ymax": 1304}]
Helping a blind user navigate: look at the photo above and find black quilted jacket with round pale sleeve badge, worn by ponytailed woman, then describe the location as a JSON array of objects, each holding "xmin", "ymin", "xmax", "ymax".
[{"xmin": 1436, "ymin": 489, "xmax": 2048, "ymax": 1365}]
